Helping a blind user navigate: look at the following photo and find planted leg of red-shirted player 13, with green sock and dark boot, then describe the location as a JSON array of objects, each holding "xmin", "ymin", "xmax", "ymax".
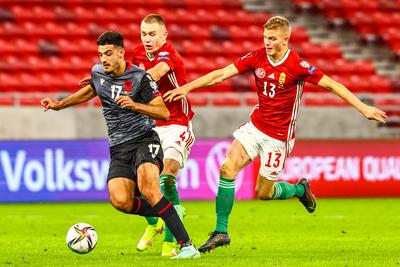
[{"xmin": 199, "ymin": 139, "xmax": 251, "ymax": 252}]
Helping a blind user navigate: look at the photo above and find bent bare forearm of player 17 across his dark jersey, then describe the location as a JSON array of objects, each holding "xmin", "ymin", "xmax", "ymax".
[{"xmin": 116, "ymin": 96, "xmax": 169, "ymax": 121}]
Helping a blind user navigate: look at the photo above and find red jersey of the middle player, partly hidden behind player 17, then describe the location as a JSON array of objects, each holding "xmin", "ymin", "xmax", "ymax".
[{"xmin": 132, "ymin": 42, "xmax": 194, "ymax": 126}]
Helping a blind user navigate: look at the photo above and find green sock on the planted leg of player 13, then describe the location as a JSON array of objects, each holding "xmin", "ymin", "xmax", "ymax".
[{"xmin": 215, "ymin": 177, "xmax": 235, "ymax": 233}]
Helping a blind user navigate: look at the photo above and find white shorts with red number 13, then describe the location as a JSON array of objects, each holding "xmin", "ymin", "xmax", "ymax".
[{"xmin": 233, "ymin": 122, "xmax": 294, "ymax": 180}]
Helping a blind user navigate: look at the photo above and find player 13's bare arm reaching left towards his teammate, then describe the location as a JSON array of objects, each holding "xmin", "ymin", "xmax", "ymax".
[{"xmin": 163, "ymin": 64, "xmax": 239, "ymax": 102}]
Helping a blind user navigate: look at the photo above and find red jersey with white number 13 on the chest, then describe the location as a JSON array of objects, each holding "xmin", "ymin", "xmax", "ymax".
[{"xmin": 234, "ymin": 48, "xmax": 324, "ymax": 141}]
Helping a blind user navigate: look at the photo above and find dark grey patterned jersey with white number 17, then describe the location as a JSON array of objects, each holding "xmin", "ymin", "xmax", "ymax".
[{"xmin": 90, "ymin": 63, "xmax": 160, "ymax": 146}]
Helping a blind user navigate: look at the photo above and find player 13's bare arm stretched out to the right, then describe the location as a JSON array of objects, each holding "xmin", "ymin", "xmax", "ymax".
[{"xmin": 318, "ymin": 75, "xmax": 387, "ymax": 123}]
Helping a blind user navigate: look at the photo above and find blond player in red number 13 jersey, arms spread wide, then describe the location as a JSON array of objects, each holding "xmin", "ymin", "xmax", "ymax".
[{"xmin": 164, "ymin": 16, "xmax": 386, "ymax": 252}]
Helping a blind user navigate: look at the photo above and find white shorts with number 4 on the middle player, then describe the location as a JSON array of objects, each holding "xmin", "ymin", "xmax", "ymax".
[{"xmin": 154, "ymin": 122, "xmax": 195, "ymax": 168}]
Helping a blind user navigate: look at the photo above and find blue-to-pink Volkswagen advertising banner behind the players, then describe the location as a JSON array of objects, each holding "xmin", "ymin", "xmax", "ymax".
[{"xmin": 0, "ymin": 139, "xmax": 254, "ymax": 202}]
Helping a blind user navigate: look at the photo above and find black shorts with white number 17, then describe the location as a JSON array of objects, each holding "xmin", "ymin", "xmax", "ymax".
[{"xmin": 107, "ymin": 130, "xmax": 164, "ymax": 182}]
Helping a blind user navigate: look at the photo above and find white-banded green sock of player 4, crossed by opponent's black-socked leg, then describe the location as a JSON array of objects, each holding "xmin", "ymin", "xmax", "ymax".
[{"xmin": 160, "ymin": 174, "xmax": 180, "ymax": 242}]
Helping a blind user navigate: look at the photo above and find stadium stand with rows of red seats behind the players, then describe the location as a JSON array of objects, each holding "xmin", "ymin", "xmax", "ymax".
[{"xmin": 0, "ymin": 0, "xmax": 400, "ymax": 132}]
